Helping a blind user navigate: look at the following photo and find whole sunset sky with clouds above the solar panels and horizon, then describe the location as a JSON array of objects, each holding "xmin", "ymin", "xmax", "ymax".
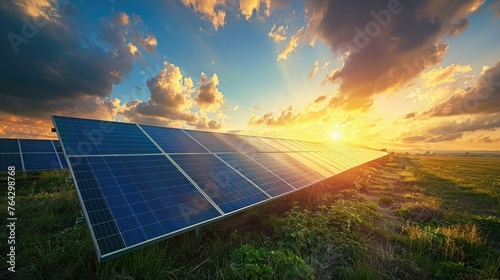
[{"xmin": 0, "ymin": 0, "xmax": 500, "ymax": 150}]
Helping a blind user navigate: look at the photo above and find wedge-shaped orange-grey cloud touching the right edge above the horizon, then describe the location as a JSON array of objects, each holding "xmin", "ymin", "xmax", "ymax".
[{"xmin": 424, "ymin": 61, "xmax": 500, "ymax": 117}]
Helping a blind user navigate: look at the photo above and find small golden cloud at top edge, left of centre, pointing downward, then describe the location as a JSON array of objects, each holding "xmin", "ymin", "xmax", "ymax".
[{"xmin": 182, "ymin": 0, "xmax": 226, "ymax": 31}]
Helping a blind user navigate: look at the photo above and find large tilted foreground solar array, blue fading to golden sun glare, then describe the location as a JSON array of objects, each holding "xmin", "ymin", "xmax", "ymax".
[{"xmin": 53, "ymin": 116, "xmax": 386, "ymax": 260}]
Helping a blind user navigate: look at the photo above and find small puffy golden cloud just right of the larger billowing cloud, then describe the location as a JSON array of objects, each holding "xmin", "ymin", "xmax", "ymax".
[{"xmin": 195, "ymin": 73, "xmax": 226, "ymax": 112}]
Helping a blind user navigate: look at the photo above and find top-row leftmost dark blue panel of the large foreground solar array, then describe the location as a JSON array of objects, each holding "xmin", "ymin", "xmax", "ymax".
[{"xmin": 54, "ymin": 116, "xmax": 160, "ymax": 155}]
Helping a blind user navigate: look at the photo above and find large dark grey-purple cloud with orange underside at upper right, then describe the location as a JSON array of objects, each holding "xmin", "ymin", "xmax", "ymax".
[{"xmin": 300, "ymin": 0, "xmax": 484, "ymax": 110}]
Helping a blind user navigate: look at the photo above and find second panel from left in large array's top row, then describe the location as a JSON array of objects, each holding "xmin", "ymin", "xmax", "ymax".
[{"xmin": 141, "ymin": 125, "xmax": 207, "ymax": 153}]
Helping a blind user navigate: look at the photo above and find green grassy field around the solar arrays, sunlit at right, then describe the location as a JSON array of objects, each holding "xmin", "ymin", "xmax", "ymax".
[{"xmin": 0, "ymin": 155, "xmax": 500, "ymax": 280}]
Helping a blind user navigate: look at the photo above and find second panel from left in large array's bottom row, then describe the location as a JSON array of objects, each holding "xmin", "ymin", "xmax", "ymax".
[{"xmin": 171, "ymin": 154, "xmax": 268, "ymax": 213}]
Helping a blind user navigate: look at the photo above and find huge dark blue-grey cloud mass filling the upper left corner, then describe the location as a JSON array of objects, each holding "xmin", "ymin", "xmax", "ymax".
[{"xmin": 0, "ymin": 1, "xmax": 156, "ymax": 122}]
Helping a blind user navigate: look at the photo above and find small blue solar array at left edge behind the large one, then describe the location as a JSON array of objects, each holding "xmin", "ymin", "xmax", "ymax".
[{"xmin": 0, "ymin": 139, "xmax": 68, "ymax": 172}]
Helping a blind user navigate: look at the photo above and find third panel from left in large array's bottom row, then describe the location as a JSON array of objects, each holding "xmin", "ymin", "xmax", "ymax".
[{"xmin": 218, "ymin": 154, "xmax": 294, "ymax": 197}]
